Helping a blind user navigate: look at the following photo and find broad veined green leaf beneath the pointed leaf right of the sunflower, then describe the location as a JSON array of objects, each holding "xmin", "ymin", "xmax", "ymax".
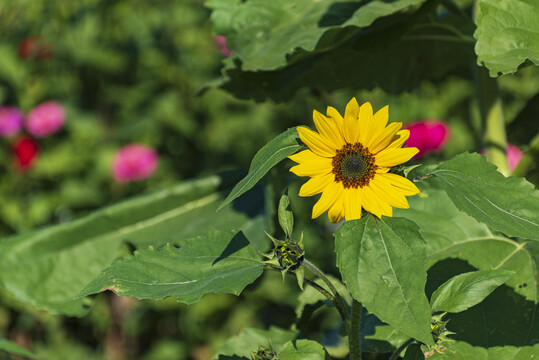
[{"xmin": 394, "ymin": 182, "xmax": 539, "ymax": 302}]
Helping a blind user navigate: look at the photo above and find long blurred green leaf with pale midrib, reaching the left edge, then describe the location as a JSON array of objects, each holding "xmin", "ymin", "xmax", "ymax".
[{"xmin": 0, "ymin": 176, "xmax": 265, "ymax": 316}]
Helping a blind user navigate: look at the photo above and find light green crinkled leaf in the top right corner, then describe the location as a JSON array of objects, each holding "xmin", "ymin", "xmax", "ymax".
[{"xmin": 474, "ymin": 0, "xmax": 539, "ymax": 77}]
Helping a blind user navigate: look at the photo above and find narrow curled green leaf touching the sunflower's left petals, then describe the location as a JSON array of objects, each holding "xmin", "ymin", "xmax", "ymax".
[{"xmin": 217, "ymin": 128, "xmax": 303, "ymax": 210}]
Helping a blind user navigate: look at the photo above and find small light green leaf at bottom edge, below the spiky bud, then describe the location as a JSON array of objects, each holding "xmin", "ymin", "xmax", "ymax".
[{"xmin": 218, "ymin": 327, "xmax": 297, "ymax": 359}]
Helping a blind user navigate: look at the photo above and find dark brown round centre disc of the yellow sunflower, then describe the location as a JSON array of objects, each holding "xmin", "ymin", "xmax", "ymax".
[{"xmin": 332, "ymin": 143, "xmax": 377, "ymax": 189}]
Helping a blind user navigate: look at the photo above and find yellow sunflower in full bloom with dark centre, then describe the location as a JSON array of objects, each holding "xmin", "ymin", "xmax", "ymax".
[{"xmin": 289, "ymin": 98, "xmax": 419, "ymax": 223}]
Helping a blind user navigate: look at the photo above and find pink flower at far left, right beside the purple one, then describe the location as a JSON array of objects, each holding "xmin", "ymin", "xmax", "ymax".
[{"xmin": 25, "ymin": 101, "xmax": 65, "ymax": 137}]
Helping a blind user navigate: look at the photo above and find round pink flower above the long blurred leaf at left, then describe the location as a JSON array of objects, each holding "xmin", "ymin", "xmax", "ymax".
[{"xmin": 112, "ymin": 144, "xmax": 159, "ymax": 184}]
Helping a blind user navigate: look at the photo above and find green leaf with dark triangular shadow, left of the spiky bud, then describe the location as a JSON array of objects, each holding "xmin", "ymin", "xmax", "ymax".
[{"xmin": 80, "ymin": 231, "xmax": 264, "ymax": 304}]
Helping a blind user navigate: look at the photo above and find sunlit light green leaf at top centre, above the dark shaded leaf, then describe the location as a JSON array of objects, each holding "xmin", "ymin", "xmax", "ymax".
[{"xmin": 206, "ymin": 0, "xmax": 425, "ymax": 71}]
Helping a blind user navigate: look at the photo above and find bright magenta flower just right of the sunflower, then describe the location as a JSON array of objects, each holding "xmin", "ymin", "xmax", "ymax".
[{"xmin": 404, "ymin": 119, "xmax": 450, "ymax": 158}]
